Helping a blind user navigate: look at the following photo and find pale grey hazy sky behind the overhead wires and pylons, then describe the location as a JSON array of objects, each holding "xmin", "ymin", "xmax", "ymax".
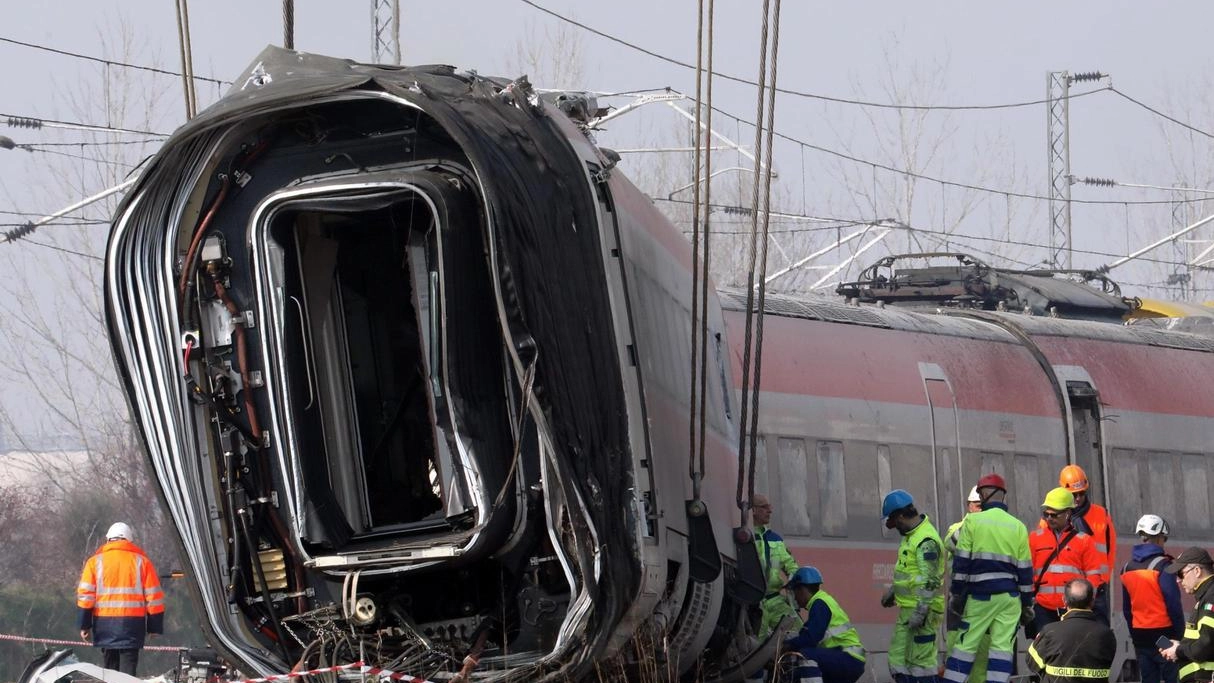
[{"xmin": 0, "ymin": 0, "xmax": 1214, "ymax": 431}]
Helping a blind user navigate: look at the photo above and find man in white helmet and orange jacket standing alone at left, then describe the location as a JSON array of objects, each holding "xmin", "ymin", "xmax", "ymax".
[{"xmin": 76, "ymin": 522, "xmax": 164, "ymax": 676}]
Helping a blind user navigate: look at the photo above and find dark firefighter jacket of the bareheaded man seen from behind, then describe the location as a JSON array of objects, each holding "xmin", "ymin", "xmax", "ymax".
[{"xmin": 1028, "ymin": 609, "xmax": 1117, "ymax": 683}]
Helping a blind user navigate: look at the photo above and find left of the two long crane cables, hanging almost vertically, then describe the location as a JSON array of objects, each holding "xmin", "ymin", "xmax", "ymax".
[{"xmin": 687, "ymin": 0, "xmax": 715, "ymax": 504}]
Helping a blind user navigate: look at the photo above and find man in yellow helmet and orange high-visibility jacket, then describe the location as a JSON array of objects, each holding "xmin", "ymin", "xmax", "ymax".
[{"xmin": 1025, "ymin": 486, "xmax": 1108, "ymax": 638}]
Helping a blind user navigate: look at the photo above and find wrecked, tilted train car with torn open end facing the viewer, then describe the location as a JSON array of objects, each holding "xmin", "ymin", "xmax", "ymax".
[{"xmin": 106, "ymin": 49, "xmax": 764, "ymax": 681}]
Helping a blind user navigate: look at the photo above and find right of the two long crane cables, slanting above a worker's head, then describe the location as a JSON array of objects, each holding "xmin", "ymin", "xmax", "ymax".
[{"xmin": 737, "ymin": 0, "xmax": 781, "ymax": 527}]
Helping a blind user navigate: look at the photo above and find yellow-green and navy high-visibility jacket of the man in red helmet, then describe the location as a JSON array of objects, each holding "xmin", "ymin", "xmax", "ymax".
[{"xmin": 948, "ymin": 502, "xmax": 1033, "ymax": 604}]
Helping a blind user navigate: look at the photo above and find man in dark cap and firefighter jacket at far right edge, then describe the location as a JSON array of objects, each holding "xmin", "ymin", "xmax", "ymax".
[{"xmin": 1159, "ymin": 546, "xmax": 1214, "ymax": 683}]
